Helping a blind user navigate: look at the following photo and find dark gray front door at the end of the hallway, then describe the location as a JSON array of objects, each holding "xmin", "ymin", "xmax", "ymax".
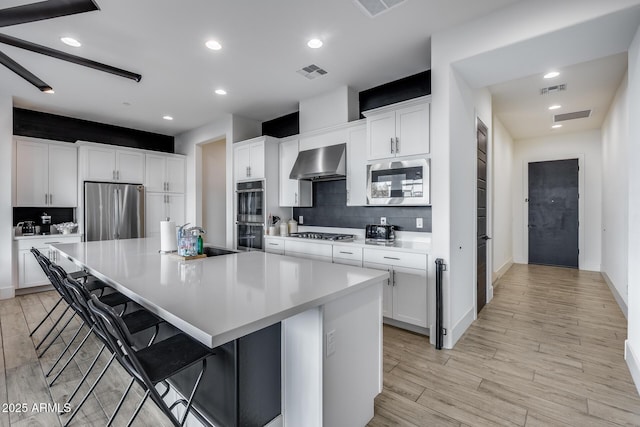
[{"xmin": 529, "ymin": 159, "xmax": 578, "ymax": 268}]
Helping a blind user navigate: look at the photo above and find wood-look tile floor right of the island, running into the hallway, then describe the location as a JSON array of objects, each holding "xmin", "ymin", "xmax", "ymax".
[{"xmin": 369, "ymin": 265, "xmax": 640, "ymax": 427}]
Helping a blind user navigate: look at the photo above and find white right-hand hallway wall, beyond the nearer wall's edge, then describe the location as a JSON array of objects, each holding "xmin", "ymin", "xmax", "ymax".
[{"xmin": 602, "ymin": 75, "xmax": 629, "ymax": 313}]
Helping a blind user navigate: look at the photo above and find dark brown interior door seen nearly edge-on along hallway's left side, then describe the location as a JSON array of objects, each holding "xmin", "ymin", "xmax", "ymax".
[{"xmin": 476, "ymin": 119, "xmax": 490, "ymax": 313}]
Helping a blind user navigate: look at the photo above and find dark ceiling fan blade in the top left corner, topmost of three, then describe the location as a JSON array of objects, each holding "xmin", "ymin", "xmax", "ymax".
[{"xmin": 0, "ymin": 0, "xmax": 100, "ymax": 27}]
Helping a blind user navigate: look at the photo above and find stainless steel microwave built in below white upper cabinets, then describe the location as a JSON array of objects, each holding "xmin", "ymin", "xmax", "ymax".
[{"xmin": 367, "ymin": 159, "xmax": 431, "ymax": 206}]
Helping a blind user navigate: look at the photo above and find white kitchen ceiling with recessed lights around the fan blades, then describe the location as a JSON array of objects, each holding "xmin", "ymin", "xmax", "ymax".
[{"xmin": 0, "ymin": 0, "xmax": 515, "ymax": 135}]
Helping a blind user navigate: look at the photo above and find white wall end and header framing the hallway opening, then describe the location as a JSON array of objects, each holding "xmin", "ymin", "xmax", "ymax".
[{"xmin": 431, "ymin": 0, "xmax": 637, "ymax": 348}]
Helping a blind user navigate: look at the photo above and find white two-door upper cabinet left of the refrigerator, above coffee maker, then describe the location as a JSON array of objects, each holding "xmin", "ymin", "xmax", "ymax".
[{"xmin": 15, "ymin": 139, "xmax": 78, "ymax": 207}]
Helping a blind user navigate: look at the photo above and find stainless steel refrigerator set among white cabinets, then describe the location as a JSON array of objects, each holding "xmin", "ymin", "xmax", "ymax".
[{"xmin": 84, "ymin": 182, "xmax": 144, "ymax": 242}]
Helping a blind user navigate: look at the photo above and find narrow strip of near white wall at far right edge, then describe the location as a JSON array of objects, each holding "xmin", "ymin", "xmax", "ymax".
[{"xmin": 625, "ymin": 22, "xmax": 640, "ymax": 392}]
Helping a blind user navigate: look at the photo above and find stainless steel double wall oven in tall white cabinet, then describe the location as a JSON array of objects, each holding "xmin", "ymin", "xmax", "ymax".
[{"xmin": 236, "ymin": 181, "xmax": 265, "ymax": 251}]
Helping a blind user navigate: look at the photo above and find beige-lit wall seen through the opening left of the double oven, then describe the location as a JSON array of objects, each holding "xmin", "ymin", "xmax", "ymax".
[{"xmin": 202, "ymin": 139, "xmax": 231, "ymax": 246}]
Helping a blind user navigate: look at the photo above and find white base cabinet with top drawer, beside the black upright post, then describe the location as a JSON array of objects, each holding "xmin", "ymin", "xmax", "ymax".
[{"xmin": 364, "ymin": 248, "xmax": 428, "ymax": 328}]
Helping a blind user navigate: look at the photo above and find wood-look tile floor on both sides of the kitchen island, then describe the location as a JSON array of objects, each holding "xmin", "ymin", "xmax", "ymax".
[{"xmin": 0, "ymin": 265, "xmax": 640, "ymax": 427}]
